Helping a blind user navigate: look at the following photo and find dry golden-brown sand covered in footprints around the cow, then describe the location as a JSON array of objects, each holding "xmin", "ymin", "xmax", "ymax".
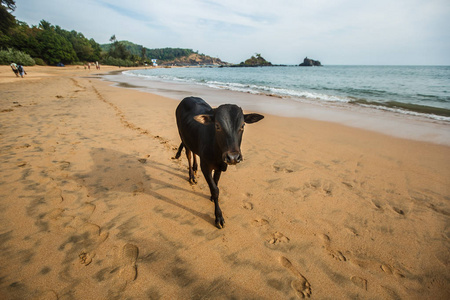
[{"xmin": 0, "ymin": 66, "xmax": 450, "ymax": 299}]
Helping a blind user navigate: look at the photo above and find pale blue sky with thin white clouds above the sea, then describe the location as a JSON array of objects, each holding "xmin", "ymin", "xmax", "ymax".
[{"xmin": 12, "ymin": 0, "xmax": 450, "ymax": 65}]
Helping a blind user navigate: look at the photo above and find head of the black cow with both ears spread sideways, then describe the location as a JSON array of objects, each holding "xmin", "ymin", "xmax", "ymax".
[{"xmin": 194, "ymin": 104, "xmax": 264, "ymax": 165}]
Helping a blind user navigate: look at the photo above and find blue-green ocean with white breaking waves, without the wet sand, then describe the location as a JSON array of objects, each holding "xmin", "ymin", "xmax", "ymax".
[{"xmin": 123, "ymin": 66, "xmax": 450, "ymax": 123}]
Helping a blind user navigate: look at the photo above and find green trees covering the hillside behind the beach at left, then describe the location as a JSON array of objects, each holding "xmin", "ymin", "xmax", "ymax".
[{"xmin": 0, "ymin": 0, "xmax": 200, "ymax": 67}]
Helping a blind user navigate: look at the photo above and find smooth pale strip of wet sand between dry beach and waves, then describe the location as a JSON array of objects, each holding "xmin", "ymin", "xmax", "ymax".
[{"xmin": 102, "ymin": 69, "xmax": 450, "ymax": 146}]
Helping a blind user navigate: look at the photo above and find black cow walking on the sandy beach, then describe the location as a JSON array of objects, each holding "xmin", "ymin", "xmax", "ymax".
[{"xmin": 175, "ymin": 97, "xmax": 264, "ymax": 228}]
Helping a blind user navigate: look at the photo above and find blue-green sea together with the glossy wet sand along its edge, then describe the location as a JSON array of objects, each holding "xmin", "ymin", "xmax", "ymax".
[{"xmin": 102, "ymin": 66, "xmax": 450, "ymax": 146}]
